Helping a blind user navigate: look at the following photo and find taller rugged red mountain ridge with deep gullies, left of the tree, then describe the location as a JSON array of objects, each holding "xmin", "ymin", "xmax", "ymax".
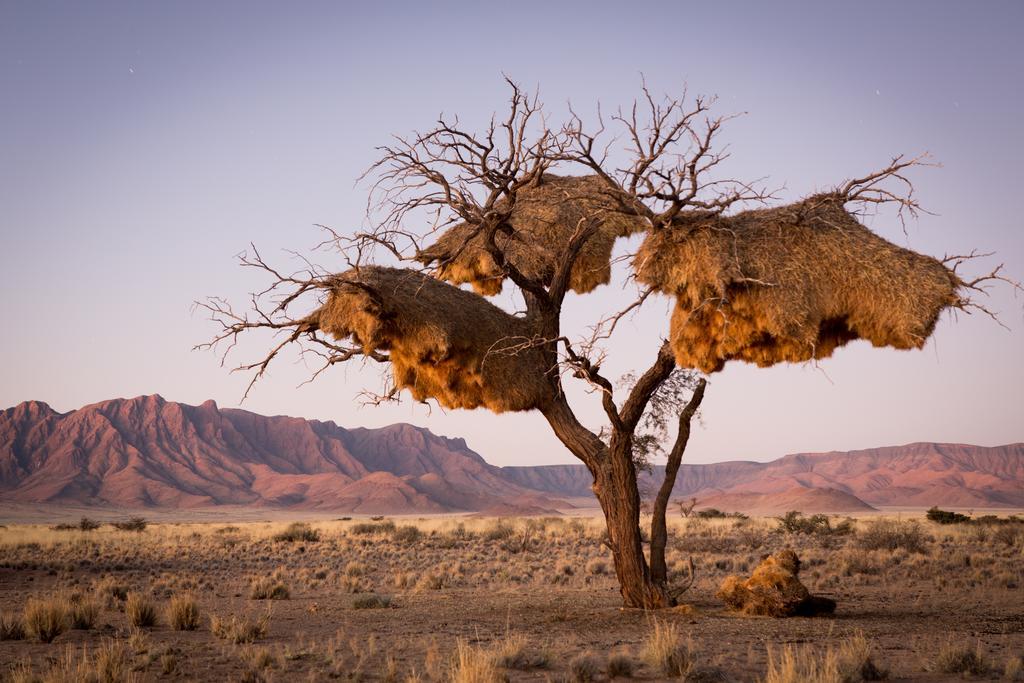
[{"xmin": 0, "ymin": 395, "xmax": 564, "ymax": 513}]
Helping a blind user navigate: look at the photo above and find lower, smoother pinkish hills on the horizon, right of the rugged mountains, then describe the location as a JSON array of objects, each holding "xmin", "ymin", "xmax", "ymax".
[{"xmin": 502, "ymin": 443, "xmax": 1024, "ymax": 512}]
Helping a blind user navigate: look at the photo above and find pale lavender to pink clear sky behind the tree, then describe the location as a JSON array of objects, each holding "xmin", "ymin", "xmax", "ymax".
[{"xmin": 0, "ymin": 0, "xmax": 1024, "ymax": 465}]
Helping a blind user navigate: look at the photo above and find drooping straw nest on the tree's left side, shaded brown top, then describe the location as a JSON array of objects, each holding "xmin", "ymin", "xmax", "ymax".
[{"xmin": 315, "ymin": 266, "xmax": 552, "ymax": 413}]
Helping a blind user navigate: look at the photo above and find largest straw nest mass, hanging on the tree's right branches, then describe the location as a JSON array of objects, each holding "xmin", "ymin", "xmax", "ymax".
[{"xmin": 634, "ymin": 195, "xmax": 964, "ymax": 373}]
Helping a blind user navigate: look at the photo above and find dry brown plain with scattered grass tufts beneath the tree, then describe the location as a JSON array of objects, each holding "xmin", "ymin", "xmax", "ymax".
[{"xmin": 0, "ymin": 517, "xmax": 1024, "ymax": 682}]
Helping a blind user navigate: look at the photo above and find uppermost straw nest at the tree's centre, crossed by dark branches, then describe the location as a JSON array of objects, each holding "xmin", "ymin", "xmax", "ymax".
[{"xmin": 417, "ymin": 174, "xmax": 647, "ymax": 296}]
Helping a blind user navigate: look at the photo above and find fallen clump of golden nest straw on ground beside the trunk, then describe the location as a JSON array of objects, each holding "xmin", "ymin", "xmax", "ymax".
[{"xmin": 716, "ymin": 549, "xmax": 836, "ymax": 616}]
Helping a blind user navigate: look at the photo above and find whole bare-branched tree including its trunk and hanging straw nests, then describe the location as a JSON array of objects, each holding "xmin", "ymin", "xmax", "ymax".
[{"xmin": 199, "ymin": 81, "xmax": 1001, "ymax": 608}]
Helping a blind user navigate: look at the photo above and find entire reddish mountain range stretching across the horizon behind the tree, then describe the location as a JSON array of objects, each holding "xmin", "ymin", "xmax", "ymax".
[{"xmin": 0, "ymin": 395, "xmax": 1024, "ymax": 514}]
